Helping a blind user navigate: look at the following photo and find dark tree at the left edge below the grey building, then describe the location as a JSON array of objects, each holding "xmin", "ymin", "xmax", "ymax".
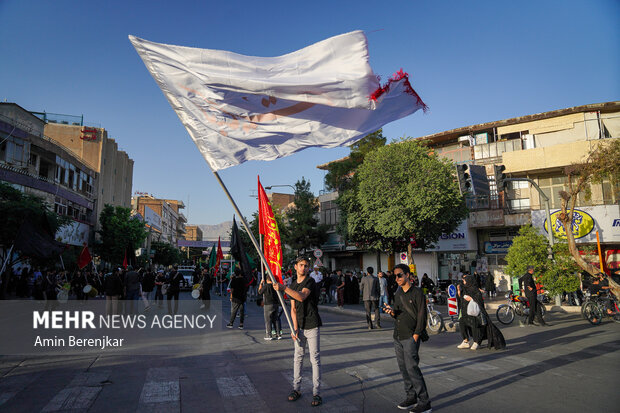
[{"xmin": 0, "ymin": 182, "xmax": 71, "ymax": 293}]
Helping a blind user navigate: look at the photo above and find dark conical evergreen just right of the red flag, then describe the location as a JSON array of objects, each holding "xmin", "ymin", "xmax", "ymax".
[{"xmin": 286, "ymin": 178, "xmax": 327, "ymax": 253}]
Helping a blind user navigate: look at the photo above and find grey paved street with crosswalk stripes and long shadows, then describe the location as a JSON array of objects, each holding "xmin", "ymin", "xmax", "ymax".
[{"xmin": 0, "ymin": 292, "xmax": 620, "ymax": 413}]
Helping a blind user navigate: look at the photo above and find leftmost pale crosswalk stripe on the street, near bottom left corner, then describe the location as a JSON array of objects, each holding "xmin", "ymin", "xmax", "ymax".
[{"xmin": 42, "ymin": 371, "xmax": 110, "ymax": 412}]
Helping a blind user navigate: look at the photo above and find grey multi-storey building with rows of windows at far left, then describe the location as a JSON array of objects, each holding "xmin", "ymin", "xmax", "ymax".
[{"xmin": 0, "ymin": 103, "xmax": 99, "ymax": 246}]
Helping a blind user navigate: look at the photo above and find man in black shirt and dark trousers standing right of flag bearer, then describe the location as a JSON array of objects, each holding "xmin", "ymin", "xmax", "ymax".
[{"xmin": 384, "ymin": 264, "xmax": 432, "ymax": 413}]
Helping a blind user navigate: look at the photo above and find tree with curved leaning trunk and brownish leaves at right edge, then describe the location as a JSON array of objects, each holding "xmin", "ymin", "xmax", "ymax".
[{"xmin": 558, "ymin": 139, "xmax": 620, "ymax": 297}]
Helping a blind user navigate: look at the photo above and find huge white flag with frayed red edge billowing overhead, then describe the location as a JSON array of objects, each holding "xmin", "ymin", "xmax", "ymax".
[{"xmin": 129, "ymin": 31, "xmax": 424, "ymax": 171}]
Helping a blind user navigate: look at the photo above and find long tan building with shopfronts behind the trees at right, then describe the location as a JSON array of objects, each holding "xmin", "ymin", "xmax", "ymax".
[{"xmin": 320, "ymin": 102, "xmax": 620, "ymax": 290}]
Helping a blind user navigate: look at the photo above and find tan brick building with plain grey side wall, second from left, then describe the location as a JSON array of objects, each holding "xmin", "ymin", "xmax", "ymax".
[{"xmin": 39, "ymin": 119, "xmax": 134, "ymax": 230}]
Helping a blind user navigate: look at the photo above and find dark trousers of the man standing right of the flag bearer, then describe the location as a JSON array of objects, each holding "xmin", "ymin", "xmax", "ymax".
[{"xmin": 394, "ymin": 337, "xmax": 430, "ymax": 404}]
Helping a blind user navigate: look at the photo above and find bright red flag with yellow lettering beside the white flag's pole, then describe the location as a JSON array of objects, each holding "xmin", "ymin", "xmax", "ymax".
[{"xmin": 258, "ymin": 177, "xmax": 282, "ymax": 284}]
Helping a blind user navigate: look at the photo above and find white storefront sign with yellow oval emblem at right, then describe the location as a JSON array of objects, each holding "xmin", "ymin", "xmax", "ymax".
[{"xmin": 532, "ymin": 205, "xmax": 620, "ymax": 243}]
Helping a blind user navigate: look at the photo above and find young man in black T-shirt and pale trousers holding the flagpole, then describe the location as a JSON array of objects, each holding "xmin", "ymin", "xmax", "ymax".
[{"xmin": 273, "ymin": 257, "xmax": 323, "ymax": 406}]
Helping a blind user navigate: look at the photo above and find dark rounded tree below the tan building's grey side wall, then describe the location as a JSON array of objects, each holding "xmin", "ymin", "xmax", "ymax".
[{"xmin": 95, "ymin": 205, "xmax": 146, "ymax": 264}]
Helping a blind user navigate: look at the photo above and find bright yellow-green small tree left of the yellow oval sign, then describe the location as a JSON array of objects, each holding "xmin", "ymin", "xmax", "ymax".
[{"xmin": 505, "ymin": 225, "xmax": 549, "ymax": 277}]
